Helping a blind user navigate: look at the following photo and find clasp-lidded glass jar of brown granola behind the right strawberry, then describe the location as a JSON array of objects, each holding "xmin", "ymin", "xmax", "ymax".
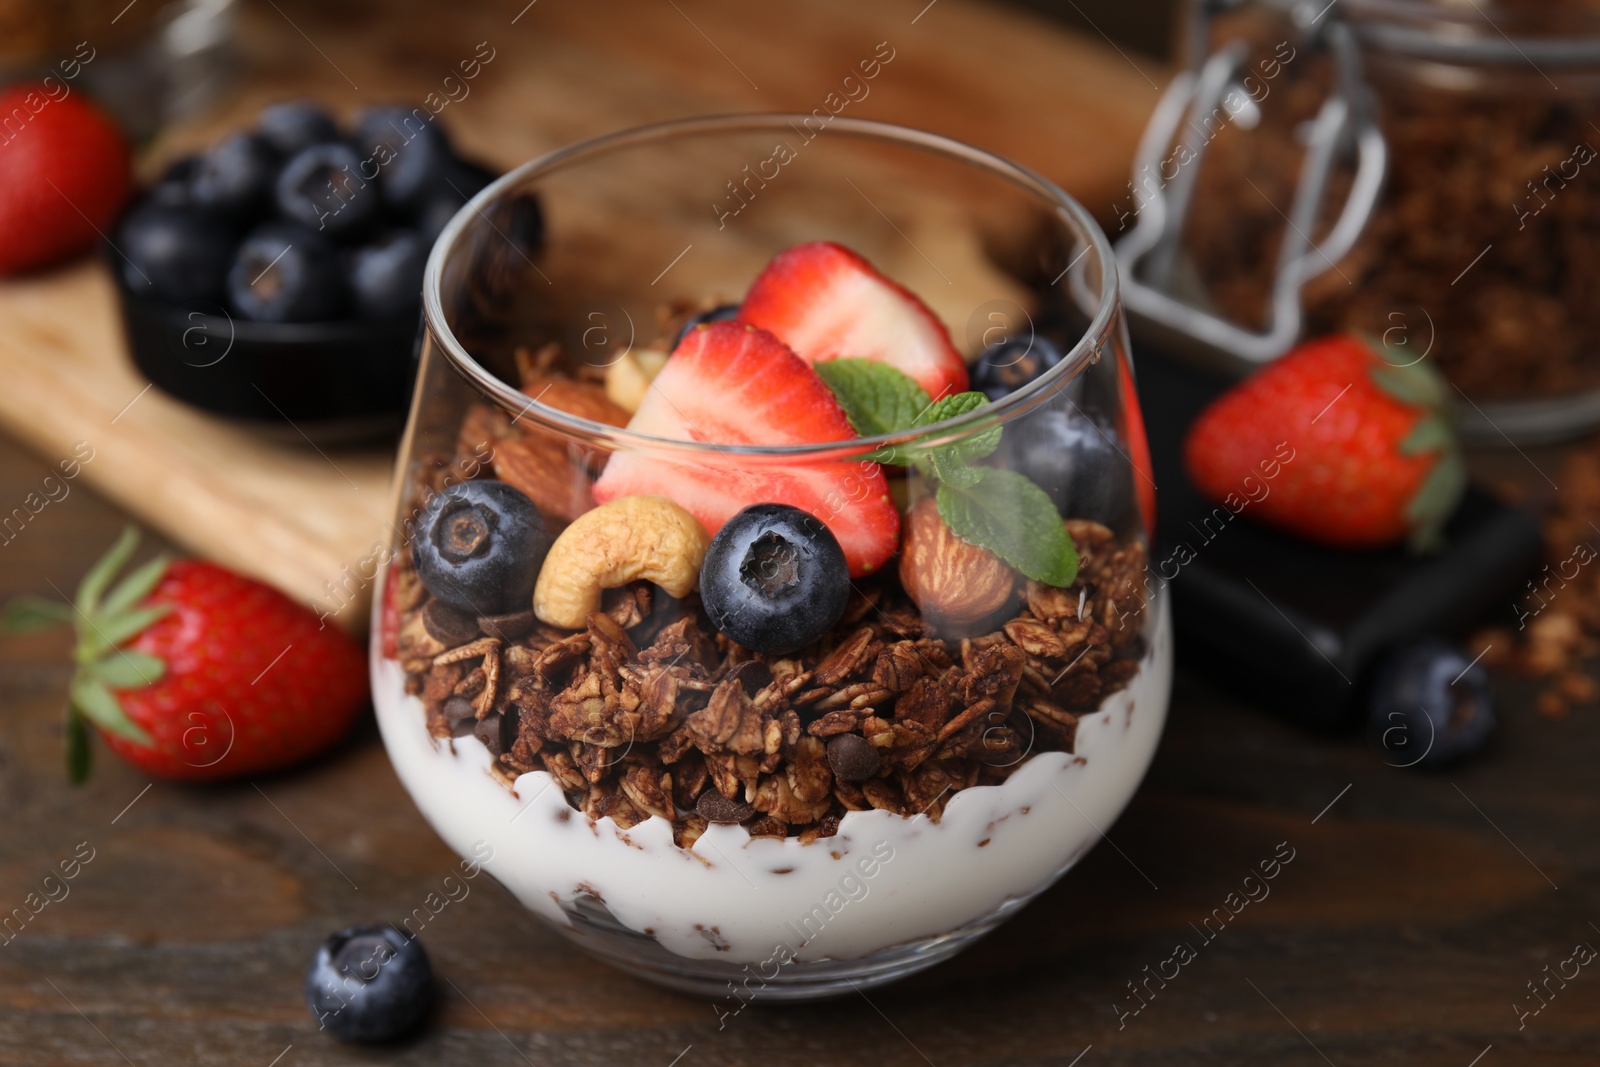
[{"xmin": 1130, "ymin": 0, "xmax": 1600, "ymax": 443}]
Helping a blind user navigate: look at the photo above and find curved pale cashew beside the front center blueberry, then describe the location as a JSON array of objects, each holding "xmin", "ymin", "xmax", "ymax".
[{"xmin": 533, "ymin": 496, "xmax": 710, "ymax": 630}]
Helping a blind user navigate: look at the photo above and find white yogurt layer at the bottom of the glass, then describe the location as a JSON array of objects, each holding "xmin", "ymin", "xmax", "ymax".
[{"xmin": 373, "ymin": 593, "xmax": 1173, "ymax": 963}]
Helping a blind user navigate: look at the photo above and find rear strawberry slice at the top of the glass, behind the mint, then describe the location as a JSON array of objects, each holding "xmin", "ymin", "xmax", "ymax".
[{"xmin": 739, "ymin": 242, "xmax": 966, "ymax": 400}]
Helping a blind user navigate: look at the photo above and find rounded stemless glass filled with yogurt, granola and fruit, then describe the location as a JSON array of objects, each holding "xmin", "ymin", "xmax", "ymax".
[{"xmin": 373, "ymin": 115, "xmax": 1171, "ymax": 1011}]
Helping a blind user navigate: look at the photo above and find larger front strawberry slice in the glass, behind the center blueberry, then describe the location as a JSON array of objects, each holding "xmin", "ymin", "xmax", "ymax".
[{"xmin": 594, "ymin": 322, "xmax": 899, "ymax": 577}]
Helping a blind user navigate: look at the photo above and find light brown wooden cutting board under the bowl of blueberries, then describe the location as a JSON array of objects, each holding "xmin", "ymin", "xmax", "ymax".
[{"xmin": 0, "ymin": 0, "xmax": 1162, "ymax": 630}]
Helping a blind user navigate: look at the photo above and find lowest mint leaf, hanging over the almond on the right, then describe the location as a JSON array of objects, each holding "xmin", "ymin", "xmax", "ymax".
[{"xmin": 934, "ymin": 467, "xmax": 1078, "ymax": 587}]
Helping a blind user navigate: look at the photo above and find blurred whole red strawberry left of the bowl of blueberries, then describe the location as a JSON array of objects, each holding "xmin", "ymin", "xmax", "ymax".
[{"xmin": 0, "ymin": 83, "xmax": 131, "ymax": 274}]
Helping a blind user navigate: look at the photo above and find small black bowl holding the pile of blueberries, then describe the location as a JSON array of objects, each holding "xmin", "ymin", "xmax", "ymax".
[{"xmin": 107, "ymin": 250, "xmax": 421, "ymax": 445}]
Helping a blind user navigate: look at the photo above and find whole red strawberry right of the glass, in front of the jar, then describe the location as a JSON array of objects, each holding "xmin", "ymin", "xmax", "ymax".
[{"xmin": 1184, "ymin": 334, "xmax": 1466, "ymax": 550}]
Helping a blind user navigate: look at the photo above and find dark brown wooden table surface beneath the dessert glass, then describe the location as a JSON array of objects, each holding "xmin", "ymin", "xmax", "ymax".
[{"xmin": 12, "ymin": 0, "xmax": 1600, "ymax": 1067}]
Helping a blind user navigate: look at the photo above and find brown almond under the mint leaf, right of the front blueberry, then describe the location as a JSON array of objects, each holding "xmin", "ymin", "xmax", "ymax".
[{"xmin": 899, "ymin": 496, "xmax": 1016, "ymax": 627}]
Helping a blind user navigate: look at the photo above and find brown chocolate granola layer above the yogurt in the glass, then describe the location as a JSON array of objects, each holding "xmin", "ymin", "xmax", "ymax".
[{"xmin": 390, "ymin": 413, "xmax": 1146, "ymax": 846}]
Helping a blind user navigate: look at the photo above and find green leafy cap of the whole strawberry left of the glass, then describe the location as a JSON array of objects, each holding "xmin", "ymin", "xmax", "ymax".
[{"xmin": 0, "ymin": 525, "xmax": 173, "ymax": 782}]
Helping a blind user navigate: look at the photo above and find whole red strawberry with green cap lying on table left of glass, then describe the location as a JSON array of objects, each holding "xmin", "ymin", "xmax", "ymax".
[{"xmin": 5, "ymin": 526, "xmax": 366, "ymax": 781}]
